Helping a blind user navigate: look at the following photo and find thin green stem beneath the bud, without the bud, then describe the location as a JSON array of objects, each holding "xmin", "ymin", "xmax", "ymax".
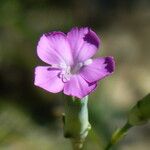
[{"xmin": 105, "ymin": 122, "xmax": 132, "ymax": 150}]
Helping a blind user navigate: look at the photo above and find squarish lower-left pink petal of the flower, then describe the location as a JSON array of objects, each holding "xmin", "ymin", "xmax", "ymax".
[{"xmin": 34, "ymin": 66, "xmax": 64, "ymax": 93}]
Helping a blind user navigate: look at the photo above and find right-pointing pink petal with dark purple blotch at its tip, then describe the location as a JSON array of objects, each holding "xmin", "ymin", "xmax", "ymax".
[{"xmin": 80, "ymin": 57, "xmax": 115, "ymax": 83}]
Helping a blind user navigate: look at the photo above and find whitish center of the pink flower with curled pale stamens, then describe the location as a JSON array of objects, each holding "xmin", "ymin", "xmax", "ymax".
[{"xmin": 59, "ymin": 59, "xmax": 92, "ymax": 82}]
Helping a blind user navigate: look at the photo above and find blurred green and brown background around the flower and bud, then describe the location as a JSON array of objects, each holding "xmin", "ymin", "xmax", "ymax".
[{"xmin": 0, "ymin": 0, "xmax": 150, "ymax": 150}]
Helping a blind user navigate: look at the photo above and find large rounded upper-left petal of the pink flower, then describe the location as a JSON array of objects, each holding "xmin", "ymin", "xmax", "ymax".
[{"xmin": 37, "ymin": 32, "xmax": 72, "ymax": 64}]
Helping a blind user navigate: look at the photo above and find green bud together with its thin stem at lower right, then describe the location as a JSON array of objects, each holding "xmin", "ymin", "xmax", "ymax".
[{"xmin": 105, "ymin": 94, "xmax": 150, "ymax": 150}]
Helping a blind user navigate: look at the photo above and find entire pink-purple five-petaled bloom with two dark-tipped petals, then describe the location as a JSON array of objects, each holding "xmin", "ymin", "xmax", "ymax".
[{"xmin": 34, "ymin": 27, "xmax": 115, "ymax": 99}]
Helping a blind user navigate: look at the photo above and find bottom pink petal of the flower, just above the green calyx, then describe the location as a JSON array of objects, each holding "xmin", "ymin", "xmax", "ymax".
[{"xmin": 64, "ymin": 75, "xmax": 97, "ymax": 99}]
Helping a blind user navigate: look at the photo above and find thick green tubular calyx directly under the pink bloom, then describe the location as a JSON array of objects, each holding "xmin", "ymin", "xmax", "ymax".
[{"xmin": 63, "ymin": 96, "xmax": 90, "ymax": 150}]
